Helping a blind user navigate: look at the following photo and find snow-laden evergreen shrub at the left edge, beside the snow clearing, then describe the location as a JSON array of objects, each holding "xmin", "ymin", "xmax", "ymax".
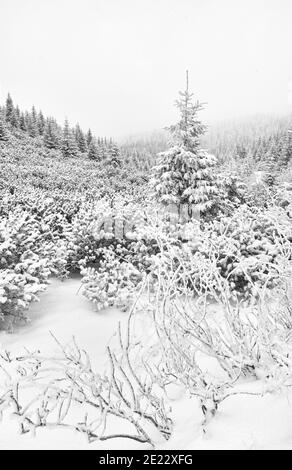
[{"xmin": 0, "ymin": 200, "xmax": 66, "ymax": 319}]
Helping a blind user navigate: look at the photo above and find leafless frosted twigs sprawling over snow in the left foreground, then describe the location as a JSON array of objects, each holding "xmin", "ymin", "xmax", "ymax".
[{"xmin": 0, "ymin": 322, "xmax": 172, "ymax": 447}]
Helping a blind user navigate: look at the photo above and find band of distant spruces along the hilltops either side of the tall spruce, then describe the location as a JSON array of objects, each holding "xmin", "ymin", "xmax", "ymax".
[{"xmin": 0, "ymin": 95, "xmax": 292, "ymax": 184}]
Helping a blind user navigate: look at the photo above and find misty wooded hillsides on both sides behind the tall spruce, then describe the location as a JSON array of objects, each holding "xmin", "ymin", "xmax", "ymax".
[{"xmin": 0, "ymin": 96, "xmax": 292, "ymax": 194}]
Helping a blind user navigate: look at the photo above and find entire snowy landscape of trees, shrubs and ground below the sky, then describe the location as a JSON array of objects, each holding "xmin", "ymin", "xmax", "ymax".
[{"xmin": 0, "ymin": 0, "xmax": 292, "ymax": 450}]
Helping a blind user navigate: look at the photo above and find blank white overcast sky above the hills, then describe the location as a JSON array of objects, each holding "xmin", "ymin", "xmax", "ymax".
[{"xmin": 0, "ymin": 0, "xmax": 292, "ymax": 136}]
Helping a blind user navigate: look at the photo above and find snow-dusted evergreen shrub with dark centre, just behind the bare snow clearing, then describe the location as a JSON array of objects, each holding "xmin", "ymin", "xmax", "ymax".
[{"xmin": 79, "ymin": 207, "xmax": 182, "ymax": 309}]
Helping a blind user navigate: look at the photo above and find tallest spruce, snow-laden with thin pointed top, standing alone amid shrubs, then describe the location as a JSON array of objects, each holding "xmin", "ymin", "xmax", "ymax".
[{"xmin": 151, "ymin": 72, "xmax": 217, "ymax": 212}]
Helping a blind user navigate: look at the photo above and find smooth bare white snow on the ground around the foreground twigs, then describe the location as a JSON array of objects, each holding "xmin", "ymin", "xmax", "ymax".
[{"xmin": 0, "ymin": 277, "xmax": 292, "ymax": 449}]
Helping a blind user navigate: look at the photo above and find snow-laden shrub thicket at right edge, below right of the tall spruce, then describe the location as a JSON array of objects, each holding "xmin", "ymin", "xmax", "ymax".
[{"xmin": 185, "ymin": 206, "xmax": 292, "ymax": 298}]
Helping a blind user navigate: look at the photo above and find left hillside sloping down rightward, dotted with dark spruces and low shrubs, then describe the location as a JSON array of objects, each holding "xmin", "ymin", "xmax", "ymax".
[{"xmin": 0, "ymin": 97, "xmax": 145, "ymax": 201}]
